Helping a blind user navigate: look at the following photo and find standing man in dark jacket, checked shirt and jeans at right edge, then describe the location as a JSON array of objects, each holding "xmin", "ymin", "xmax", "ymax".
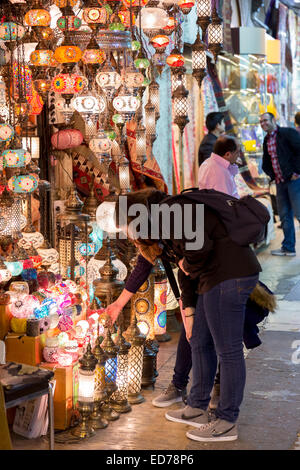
[{"xmin": 260, "ymin": 113, "xmax": 300, "ymax": 256}]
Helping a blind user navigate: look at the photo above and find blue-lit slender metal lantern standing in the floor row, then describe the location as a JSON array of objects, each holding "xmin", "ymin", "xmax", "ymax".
[{"xmin": 102, "ymin": 328, "xmax": 119, "ymax": 421}]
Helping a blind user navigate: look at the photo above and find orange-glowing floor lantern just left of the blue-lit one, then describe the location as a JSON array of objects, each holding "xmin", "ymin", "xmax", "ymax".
[{"xmin": 90, "ymin": 336, "xmax": 108, "ymax": 429}]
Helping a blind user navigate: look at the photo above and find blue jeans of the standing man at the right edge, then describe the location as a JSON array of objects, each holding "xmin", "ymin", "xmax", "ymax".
[{"xmin": 276, "ymin": 178, "xmax": 300, "ymax": 251}]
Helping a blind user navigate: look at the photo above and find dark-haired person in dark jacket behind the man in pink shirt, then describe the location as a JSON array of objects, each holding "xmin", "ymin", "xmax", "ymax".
[{"xmin": 198, "ymin": 112, "xmax": 225, "ymax": 166}]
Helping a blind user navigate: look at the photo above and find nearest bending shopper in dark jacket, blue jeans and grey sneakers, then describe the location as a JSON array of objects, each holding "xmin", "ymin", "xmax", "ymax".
[{"xmin": 106, "ymin": 189, "xmax": 261, "ymax": 441}]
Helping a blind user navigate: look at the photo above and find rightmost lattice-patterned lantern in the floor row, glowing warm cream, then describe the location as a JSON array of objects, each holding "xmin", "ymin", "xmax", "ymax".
[{"xmin": 124, "ymin": 314, "xmax": 146, "ymax": 405}]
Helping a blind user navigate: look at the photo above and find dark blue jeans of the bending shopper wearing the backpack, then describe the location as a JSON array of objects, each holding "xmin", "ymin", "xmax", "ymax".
[{"xmin": 187, "ymin": 275, "xmax": 258, "ymax": 422}]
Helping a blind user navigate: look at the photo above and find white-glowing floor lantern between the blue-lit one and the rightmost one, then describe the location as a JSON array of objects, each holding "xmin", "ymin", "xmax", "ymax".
[{"xmin": 111, "ymin": 322, "xmax": 131, "ymax": 413}]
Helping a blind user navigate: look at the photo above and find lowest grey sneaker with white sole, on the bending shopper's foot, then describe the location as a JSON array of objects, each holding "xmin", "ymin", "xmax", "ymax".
[{"xmin": 186, "ymin": 419, "xmax": 238, "ymax": 442}]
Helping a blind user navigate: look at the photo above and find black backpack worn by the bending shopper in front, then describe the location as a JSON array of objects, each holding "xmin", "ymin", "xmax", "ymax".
[{"xmin": 162, "ymin": 188, "xmax": 270, "ymax": 246}]
